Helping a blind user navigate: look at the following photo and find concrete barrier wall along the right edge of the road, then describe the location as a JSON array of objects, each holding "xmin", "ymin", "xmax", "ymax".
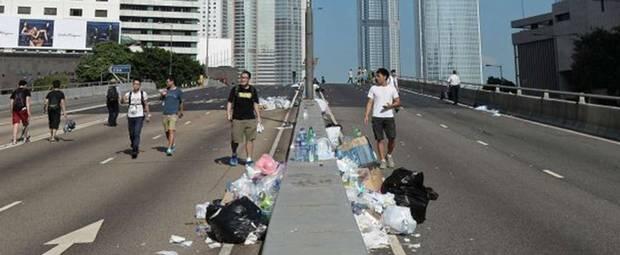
[{"xmin": 399, "ymin": 80, "xmax": 620, "ymax": 141}]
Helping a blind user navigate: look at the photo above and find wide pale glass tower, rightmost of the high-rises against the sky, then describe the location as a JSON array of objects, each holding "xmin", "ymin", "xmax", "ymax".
[{"xmin": 415, "ymin": 0, "xmax": 482, "ymax": 83}]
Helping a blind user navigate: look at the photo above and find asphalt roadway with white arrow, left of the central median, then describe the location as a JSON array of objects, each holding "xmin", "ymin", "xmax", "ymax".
[{"xmin": 0, "ymin": 84, "xmax": 293, "ymax": 255}]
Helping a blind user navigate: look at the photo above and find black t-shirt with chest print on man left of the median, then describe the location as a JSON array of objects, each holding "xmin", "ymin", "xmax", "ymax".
[{"xmin": 228, "ymin": 85, "xmax": 258, "ymax": 120}]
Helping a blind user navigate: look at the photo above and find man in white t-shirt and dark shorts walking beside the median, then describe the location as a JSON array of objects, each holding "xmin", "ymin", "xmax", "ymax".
[{"xmin": 364, "ymin": 68, "xmax": 400, "ymax": 169}]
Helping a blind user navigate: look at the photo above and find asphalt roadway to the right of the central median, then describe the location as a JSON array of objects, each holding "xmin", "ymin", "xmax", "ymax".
[{"xmin": 325, "ymin": 85, "xmax": 620, "ymax": 254}]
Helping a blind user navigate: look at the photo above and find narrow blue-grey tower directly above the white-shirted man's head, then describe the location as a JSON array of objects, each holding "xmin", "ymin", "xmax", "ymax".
[{"xmin": 357, "ymin": 0, "xmax": 400, "ymax": 72}]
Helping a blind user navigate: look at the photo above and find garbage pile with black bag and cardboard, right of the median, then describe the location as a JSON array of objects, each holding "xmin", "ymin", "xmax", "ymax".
[{"xmin": 336, "ymin": 130, "xmax": 439, "ymax": 249}]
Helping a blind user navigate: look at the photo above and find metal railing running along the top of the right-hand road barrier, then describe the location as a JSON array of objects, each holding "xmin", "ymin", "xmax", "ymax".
[{"xmin": 399, "ymin": 76, "xmax": 620, "ymax": 106}]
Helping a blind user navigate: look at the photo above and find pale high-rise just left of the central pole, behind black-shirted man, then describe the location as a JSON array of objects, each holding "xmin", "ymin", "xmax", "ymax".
[{"xmin": 233, "ymin": 0, "xmax": 303, "ymax": 85}]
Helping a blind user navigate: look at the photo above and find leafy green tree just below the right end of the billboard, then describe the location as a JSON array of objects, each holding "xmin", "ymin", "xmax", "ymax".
[{"xmin": 76, "ymin": 42, "xmax": 132, "ymax": 82}]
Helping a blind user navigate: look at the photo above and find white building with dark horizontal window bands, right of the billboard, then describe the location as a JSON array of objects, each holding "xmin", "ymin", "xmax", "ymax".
[{"xmin": 120, "ymin": 0, "xmax": 204, "ymax": 57}]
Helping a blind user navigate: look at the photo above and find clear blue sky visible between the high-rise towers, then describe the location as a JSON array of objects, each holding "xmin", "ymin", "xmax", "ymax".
[{"xmin": 313, "ymin": 0, "xmax": 554, "ymax": 82}]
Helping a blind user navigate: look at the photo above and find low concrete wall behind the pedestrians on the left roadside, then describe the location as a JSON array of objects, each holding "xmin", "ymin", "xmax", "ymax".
[{"xmin": 0, "ymin": 82, "xmax": 157, "ymax": 110}]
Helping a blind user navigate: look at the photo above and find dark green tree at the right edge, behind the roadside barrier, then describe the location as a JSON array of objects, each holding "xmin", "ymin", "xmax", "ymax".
[{"xmin": 572, "ymin": 27, "xmax": 620, "ymax": 95}]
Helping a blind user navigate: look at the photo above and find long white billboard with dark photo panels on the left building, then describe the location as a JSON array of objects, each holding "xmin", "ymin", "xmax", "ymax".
[{"xmin": 0, "ymin": 16, "xmax": 120, "ymax": 50}]
